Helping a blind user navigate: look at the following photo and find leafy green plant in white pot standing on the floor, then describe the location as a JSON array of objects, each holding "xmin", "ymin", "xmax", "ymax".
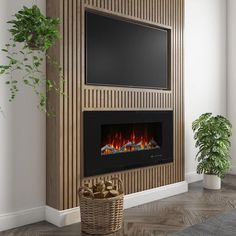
[{"xmin": 192, "ymin": 113, "xmax": 232, "ymax": 189}]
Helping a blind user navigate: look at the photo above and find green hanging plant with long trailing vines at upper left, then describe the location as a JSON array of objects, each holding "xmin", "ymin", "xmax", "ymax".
[{"xmin": 0, "ymin": 5, "xmax": 63, "ymax": 114}]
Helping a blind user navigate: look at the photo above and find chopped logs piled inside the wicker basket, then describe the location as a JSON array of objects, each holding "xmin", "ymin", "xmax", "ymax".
[{"xmin": 83, "ymin": 180, "xmax": 123, "ymax": 199}]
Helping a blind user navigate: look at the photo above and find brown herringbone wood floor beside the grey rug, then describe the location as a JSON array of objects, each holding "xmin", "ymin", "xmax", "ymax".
[{"xmin": 0, "ymin": 175, "xmax": 236, "ymax": 236}]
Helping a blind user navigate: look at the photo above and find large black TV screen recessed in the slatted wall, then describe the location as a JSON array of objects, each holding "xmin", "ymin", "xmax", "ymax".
[{"xmin": 86, "ymin": 12, "xmax": 169, "ymax": 89}]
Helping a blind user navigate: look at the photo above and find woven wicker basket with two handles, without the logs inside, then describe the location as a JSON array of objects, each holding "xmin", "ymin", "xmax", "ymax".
[{"xmin": 79, "ymin": 178, "xmax": 124, "ymax": 234}]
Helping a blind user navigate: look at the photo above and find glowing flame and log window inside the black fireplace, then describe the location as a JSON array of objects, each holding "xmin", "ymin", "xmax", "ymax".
[{"xmin": 101, "ymin": 122, "xmax": 162, "ymax": 155}]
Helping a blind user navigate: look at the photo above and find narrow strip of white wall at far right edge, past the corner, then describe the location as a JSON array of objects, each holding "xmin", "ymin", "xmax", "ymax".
[{"xmin": 227, "ymin": 0, "xmax": 236, "ymax": 174}]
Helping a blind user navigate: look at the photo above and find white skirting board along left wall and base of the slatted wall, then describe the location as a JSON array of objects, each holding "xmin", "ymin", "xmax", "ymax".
[{"xmin": 0, "ymin": 181, "xmax": 188, "ymax": 231}]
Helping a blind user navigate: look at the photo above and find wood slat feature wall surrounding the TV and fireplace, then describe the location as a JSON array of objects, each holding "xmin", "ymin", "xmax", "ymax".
[{"xmin": 47, "ymin": 0, "xmax": 184, "ymax": 210}]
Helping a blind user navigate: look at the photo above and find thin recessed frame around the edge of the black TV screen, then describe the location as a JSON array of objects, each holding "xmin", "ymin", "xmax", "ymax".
[{"xmin": 84, "ymin": 8, "xmax": 172, "ymax": 91}]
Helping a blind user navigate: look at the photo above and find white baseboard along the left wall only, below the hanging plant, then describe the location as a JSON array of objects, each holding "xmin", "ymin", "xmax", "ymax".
[{"xmin": 0, "ymin": 206, "xmax": 45, "ymax": 231}]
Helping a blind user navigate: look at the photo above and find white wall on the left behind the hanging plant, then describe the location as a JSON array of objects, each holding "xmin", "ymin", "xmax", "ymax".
[{"xmin": 0, "ymin": 0, "xmax": 46, "ymax": 231}]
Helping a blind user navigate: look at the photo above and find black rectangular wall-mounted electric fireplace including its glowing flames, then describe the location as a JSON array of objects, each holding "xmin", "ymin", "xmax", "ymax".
[{"xmin": 84, "ymin": 111, "xmax": 173, "ymax": 177}]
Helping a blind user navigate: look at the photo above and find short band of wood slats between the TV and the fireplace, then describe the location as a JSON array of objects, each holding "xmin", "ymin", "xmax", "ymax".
[{"xmin": 82, "ymin": 86, "xmax": 173, "ymax": 111}]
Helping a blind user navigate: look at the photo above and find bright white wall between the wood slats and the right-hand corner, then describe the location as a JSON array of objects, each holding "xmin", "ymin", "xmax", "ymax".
[{"xmin": 184, "ymin": 0, "xmax": 227, "ymax": 181}]
